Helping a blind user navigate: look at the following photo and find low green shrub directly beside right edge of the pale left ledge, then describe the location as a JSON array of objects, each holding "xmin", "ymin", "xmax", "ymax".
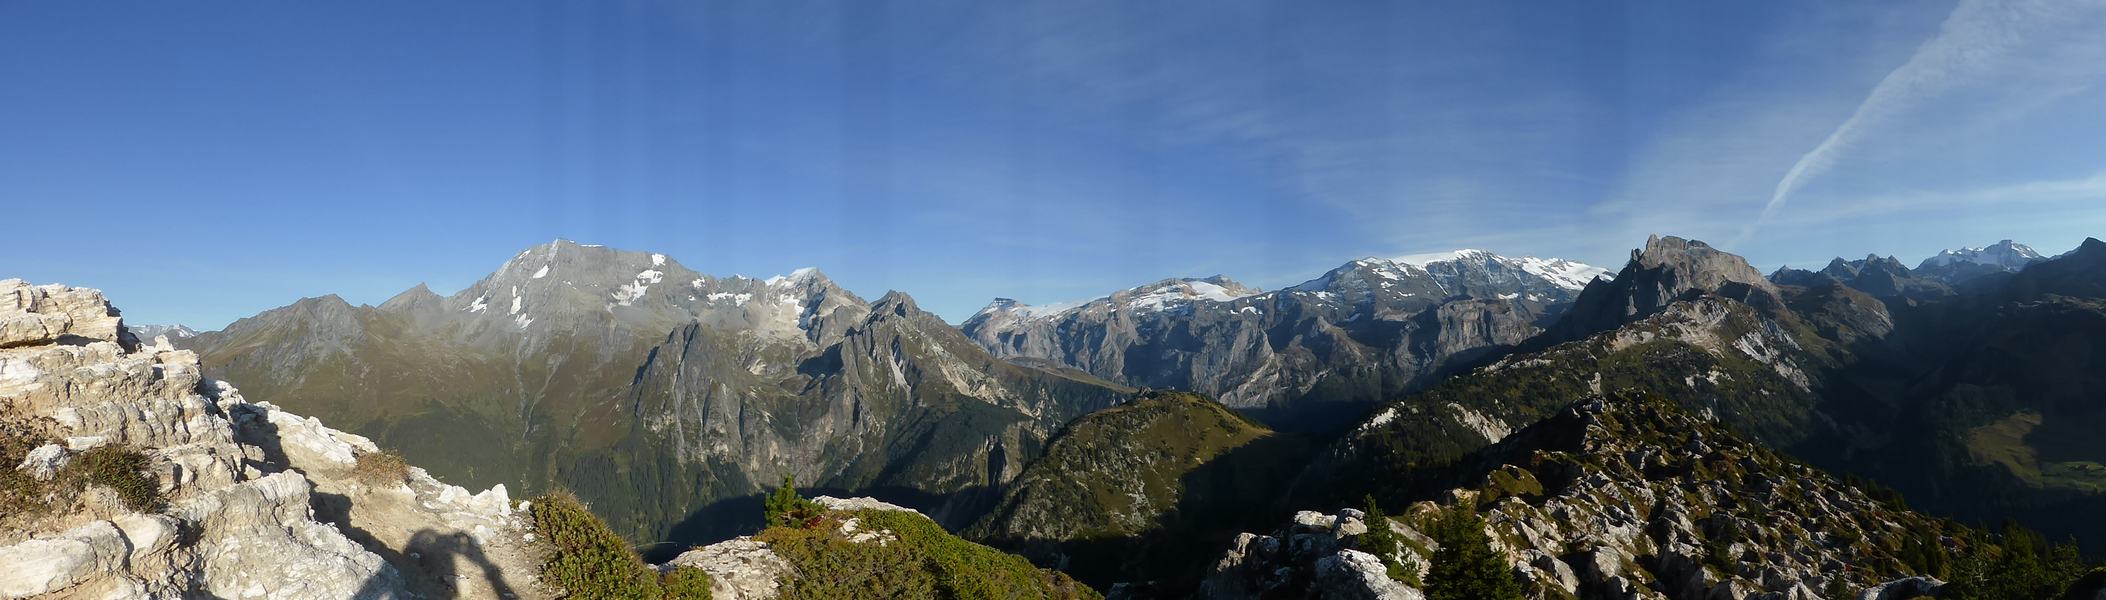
[{"xmin": 529, "ymin": 491, "xmax": 710, "ymax": 598}]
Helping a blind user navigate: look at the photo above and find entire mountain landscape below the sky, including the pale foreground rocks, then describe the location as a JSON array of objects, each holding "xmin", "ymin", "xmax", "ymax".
[{"xmin": 16, "ymin": 236, "xmax": 2106, "ymax": 600}]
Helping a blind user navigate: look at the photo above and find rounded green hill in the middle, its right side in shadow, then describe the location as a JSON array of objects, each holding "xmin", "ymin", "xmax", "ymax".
[{"xmin": 965, "ymin": 392, "xmax": 1310, "ymax": 592}]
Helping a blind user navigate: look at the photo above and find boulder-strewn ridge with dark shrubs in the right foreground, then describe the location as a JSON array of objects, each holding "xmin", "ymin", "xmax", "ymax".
[{"xmin": 1203, "ymin": 394, "xmax": 1978, "ymax": 598}]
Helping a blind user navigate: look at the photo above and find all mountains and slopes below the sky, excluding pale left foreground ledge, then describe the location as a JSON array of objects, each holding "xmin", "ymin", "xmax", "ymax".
[{"xmin": 90, "ymin": 236, "xmax": 2106, "ymax": 598}]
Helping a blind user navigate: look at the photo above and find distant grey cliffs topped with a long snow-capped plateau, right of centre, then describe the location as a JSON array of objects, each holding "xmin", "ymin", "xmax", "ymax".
[{"xmin": 962, "ymin": 251, "xmax": 1607, "ymax": 429}]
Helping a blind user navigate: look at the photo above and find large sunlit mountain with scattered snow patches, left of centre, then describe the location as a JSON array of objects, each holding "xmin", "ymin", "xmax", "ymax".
[{"xmin": 187, "ymin": 240, "xmax": 1127, "ymax": 541}]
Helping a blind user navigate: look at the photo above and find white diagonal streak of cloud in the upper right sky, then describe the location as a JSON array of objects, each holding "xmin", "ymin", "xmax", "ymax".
[{"xmin": 1735, "ymin": 0, "xmax": 2100, "ymax": 244}]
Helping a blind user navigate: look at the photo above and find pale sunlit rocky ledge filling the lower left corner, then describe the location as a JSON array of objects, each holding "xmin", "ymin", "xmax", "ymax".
[{"xmin": 0, "ymin": 280, "xmax": 550, "ymax": 598}]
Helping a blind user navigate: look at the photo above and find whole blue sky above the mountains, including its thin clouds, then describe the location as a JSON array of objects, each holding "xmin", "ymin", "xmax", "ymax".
[{"xmin": 0, "ymin": 0, "xmax": 2106, "ymax": 328}]
